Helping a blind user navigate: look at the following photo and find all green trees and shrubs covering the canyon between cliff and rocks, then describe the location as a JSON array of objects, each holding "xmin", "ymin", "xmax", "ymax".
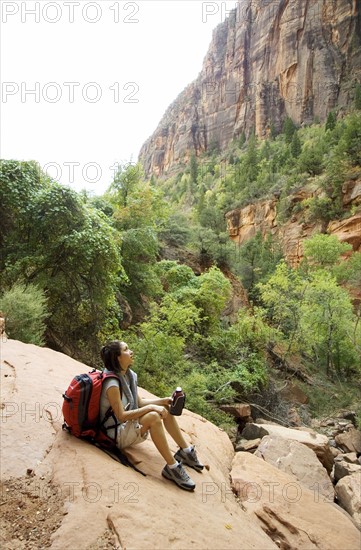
[{"xmin": 0, "ymin": 104, "xmax": 361, "ymax": 432}]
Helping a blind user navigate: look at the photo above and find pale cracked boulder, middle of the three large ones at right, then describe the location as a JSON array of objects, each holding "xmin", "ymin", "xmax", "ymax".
[{"xmin": 255, "ymin": 435, "xmax": 335, "ymax": 500}]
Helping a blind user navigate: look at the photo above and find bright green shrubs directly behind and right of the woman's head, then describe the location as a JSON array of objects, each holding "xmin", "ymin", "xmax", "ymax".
[{"xmin": 122, "ymin": 270, "xmax": 267, "ymax": 423}]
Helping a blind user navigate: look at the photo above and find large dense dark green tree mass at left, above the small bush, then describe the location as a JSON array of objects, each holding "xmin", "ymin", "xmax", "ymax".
[{"xmin": 1, "ymin": 164, "xmax": 125, "ymax": 362}]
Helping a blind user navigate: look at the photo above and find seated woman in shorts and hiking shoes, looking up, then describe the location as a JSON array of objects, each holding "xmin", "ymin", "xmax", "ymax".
[{"xmin": 100, "ymin": 340, "xmax": 203, "ymax": 491}]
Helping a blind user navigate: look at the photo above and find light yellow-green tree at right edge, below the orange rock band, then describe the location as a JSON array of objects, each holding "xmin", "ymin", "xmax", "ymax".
[{"xmin": 259, "ymin": 256, "xmax": 361, "ymax": 376}]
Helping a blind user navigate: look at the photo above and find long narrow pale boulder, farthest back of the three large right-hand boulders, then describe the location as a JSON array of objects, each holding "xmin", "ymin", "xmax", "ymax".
[{"xmin": 242, "ymin": 424, "xmax": 334, "ymax": 473}]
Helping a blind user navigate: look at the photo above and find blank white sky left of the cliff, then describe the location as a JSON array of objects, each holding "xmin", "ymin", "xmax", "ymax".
[{"xmin": 0, "ymin": 0, "xmax": 236, "ymax": 194}]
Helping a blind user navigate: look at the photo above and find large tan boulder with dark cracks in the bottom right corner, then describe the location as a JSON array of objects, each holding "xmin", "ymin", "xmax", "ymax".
[{"xmin": 231, "ymin": 453, "xmax": 360, "ymax": 550}]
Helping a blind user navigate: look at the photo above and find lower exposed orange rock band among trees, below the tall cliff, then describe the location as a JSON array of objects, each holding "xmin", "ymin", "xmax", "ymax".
[{"xmin": 226, "ymin": 180, "xmax": 361, "ymax": 267}]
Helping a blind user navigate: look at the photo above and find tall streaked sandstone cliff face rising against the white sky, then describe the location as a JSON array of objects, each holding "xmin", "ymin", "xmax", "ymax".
[{"xmin": 140, "ymin": 0, "xmax": 361, "ymax": 175}]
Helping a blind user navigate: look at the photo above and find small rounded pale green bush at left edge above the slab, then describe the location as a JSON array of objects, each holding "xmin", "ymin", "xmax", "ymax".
[{"xmin": 0, "ymin": 283, "xmax": 48, "ymax": 346}]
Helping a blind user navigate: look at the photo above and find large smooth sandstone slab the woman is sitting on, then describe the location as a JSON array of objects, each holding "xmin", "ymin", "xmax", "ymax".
[{"xmin": 0, "ymin": 340, "xmax": 277, "ymax": 550}]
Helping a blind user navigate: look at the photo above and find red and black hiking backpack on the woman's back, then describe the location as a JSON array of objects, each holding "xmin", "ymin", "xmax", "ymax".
[{"xmin": 62, "ymin": 369, "xmax": 145, "ymax": 475}]
